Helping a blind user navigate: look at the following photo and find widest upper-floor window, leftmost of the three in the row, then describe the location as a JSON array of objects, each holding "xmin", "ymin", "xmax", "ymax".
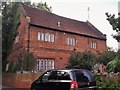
[{"xmin": 38, "ymin": 32, "xmax": 55, "ymax": 42}]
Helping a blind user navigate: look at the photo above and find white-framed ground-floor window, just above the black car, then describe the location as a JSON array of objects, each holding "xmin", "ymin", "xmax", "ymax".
[{"xmin": 37, "ymin": 59, "xmax": 54, "ymax": 71}]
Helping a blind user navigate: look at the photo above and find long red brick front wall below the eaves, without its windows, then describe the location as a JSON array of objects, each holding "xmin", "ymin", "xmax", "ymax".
[{"xmin": 30, "ymin": 26, "xmax": 106, "ymax": 68}]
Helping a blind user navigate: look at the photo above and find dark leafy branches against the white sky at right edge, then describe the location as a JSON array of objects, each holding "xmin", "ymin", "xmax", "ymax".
[{"xmin": 106, "ymin": 13, "xmax": 120, "ymax": 42}]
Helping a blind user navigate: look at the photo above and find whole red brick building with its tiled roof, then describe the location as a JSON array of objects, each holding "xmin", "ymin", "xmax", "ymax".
[{"xmin": 9, "ymin": 4, "xmax": 106, "ymax": 71}]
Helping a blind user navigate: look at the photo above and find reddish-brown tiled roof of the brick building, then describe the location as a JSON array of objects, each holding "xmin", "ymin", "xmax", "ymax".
[{"xmin": 21, "ymin": 4, "xmax": 106, "ymax": 40}]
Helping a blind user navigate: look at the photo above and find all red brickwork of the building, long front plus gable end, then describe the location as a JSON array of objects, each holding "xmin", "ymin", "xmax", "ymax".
[{"xmin": 9, "ymin": 15, "xmax": 106, "ymax": 68}]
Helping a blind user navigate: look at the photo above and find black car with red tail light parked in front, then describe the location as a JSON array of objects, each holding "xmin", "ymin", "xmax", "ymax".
[{"xmin": 31, "ymin": 69, "xmax": 96, "ymax": 90}]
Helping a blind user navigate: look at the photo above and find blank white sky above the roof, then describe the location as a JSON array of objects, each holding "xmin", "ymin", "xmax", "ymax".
[{"xmin": 31, "ymin": 0, "xmax": 120, "ymax": 49}]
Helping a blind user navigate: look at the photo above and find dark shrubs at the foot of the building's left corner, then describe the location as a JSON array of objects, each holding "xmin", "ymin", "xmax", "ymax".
[{"xmin": 8, "ymin": 52, "xmax": 36, "ymax": 73}]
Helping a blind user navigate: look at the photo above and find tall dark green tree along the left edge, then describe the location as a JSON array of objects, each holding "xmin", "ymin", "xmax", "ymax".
[{"xmin": 2, "ymin": 2, "xmax": 19, "ymax": 71}]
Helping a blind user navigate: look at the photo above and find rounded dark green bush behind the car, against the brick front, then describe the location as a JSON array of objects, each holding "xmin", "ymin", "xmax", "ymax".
[{"xmin": 66, "ymin": 51, "xmax": 94, "ymax": 70}]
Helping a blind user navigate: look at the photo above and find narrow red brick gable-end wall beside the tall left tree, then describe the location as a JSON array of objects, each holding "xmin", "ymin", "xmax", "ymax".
[{"xmin": 8, "ymin": 15, "xmax": 28, "ymax": 61}]
